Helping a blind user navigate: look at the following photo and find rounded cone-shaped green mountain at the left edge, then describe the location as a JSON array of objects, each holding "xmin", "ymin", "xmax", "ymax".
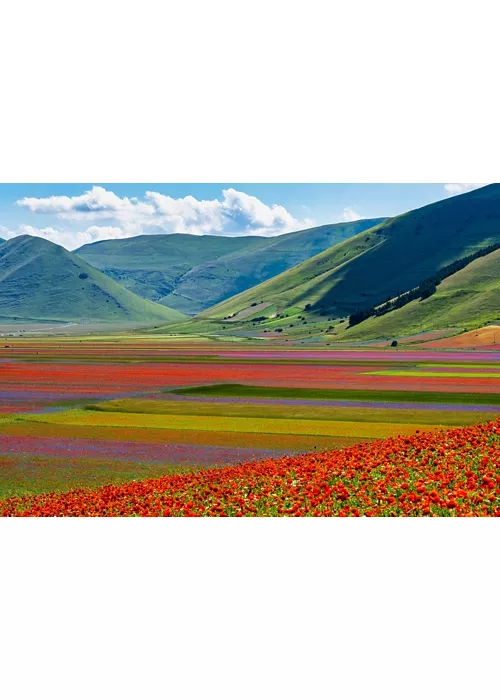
[{"xmin": 0, "ymin": 236, "xmax": 183, "ymax": 323}]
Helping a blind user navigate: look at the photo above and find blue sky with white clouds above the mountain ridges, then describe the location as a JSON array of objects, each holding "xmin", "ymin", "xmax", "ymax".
[{"xmin": 0, "ymin": 182, "xmax": 486, "ymax": 250}]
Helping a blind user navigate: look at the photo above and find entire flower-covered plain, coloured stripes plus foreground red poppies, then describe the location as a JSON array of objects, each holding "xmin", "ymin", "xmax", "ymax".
[{"xmin": 0, "ymin": 337, "xmax": 500, "ymax": 516}]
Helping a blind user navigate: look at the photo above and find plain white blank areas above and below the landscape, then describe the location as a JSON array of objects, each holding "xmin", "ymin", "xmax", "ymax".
[{"xmin": 0, "ymin": 0, "xmax": 499, "ymax": 700}]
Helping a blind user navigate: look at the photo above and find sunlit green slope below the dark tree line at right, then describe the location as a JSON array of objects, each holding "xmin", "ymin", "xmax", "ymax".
[{"xmin": 343, "ymin": 250, "xmax": 500, "ymax": 340}]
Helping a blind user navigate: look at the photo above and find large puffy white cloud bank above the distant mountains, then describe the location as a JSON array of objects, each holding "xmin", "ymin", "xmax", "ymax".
[{"xmin": 16, "ymin": 186, "xmax": 314, "ymax": 237}]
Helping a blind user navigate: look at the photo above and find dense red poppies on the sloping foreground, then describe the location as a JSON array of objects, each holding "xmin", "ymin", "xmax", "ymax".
[{"xmin": 0, "ymin": 421, "xmax": 500, "ymax": 517}]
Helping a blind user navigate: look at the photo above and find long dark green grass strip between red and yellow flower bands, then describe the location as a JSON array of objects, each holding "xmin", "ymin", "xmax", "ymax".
[{"xmin": 170, "ymin": 382, "xmax": 500, "ymax": 406}]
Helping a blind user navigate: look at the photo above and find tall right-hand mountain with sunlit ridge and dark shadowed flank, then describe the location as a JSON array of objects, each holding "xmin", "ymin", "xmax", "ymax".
[{"xmin": 198, "ymin": 184, "xmax": 500, "ymax": 330}]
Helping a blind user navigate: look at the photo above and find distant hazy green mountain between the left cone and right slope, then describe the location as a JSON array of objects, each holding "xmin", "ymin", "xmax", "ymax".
[{"xmin": 75, "ymin": 219, "xmax": 383, "ymax": 315}]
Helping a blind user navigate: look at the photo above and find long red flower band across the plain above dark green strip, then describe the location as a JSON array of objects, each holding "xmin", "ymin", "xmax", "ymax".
[{"xmin": 0, "ymin": 362, "xmax": 500, "ymax": 395}]
